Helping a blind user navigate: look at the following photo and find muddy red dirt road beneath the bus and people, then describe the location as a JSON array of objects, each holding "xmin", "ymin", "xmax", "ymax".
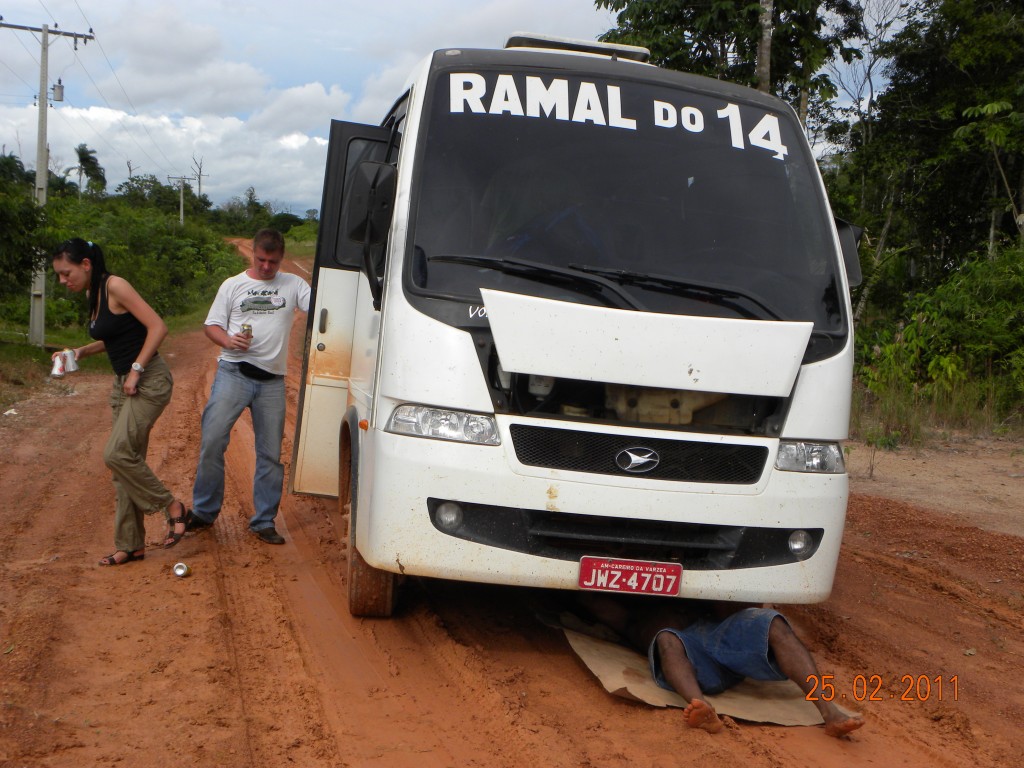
[{"xmin": 0, "ymin": 249, "xmax": 1024, "ymax": 768}]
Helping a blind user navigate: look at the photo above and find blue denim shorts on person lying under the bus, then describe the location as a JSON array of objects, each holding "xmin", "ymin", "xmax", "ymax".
[{"xmin": 647, "ymin": 608, "xmax": 786, "ymax": 694}]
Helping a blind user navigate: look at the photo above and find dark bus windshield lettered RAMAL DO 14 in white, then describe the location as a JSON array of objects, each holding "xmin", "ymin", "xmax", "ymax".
[{"xmin": 407, "ymin": 68, "xmax": 846, "ymax": 351}]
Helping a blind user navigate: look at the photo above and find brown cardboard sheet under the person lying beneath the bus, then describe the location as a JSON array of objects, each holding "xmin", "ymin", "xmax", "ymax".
[{"xmin": 562, "ymin": 627, "xmax": 823, "ymax": 725}]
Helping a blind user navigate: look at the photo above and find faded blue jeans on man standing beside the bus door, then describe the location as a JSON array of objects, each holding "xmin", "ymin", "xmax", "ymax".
[{"xmin": 193, "ymin": 360, "xmax": 285, "ymax": 530}]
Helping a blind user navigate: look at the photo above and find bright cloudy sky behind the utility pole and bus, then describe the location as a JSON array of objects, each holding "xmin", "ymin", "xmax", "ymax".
[{"xmin": 0, "ymin": 0, "xmax": 614, "ymax": 216}]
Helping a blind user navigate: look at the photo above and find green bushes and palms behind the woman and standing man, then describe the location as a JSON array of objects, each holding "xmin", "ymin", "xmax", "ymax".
[{"xmin": 0, "ymin": 144, "xmax": 292, "ymax": 330}]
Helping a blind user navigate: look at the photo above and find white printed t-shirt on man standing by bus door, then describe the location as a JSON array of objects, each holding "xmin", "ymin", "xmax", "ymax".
[{"xmin": 206, "ymin": 272, "xmax": 310, "ymax": 376}]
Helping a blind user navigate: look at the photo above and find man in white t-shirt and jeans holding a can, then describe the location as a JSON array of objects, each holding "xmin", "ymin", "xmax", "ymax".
[{"xmin": 187, "ymin": 229, "xmax": 309, "ymax": 544}]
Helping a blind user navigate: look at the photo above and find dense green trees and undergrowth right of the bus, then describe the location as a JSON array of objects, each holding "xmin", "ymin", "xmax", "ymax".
[{"xmin": 596, "ymin": 0, "xmax": 1024, "ymax": 439}]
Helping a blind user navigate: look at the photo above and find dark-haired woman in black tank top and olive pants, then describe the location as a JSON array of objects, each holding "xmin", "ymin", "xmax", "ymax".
[{"xmin": 53, "ymin": 238, "xmax": 188, "ymax": 565}]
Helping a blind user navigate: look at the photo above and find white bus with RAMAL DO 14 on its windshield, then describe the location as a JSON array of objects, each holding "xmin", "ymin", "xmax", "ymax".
[{"xmin": 291, "ymin": 36, "xmax": 859, "ymax": 616}]
